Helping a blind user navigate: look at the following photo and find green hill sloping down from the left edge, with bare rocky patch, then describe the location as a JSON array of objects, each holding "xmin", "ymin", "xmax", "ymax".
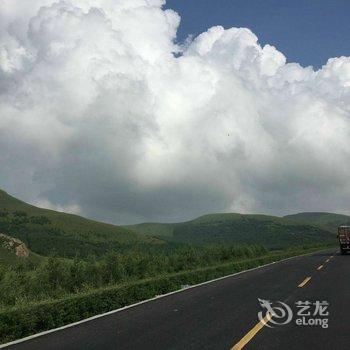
[{"xmin": 0, "ymin": 190, "xmax": 159, "ymax": 257}]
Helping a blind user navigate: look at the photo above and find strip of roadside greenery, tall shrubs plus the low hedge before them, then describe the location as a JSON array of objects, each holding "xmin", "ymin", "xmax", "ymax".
[{"xmin": 0, "ymin": 242, "xmax": 334, "ymax": 343}]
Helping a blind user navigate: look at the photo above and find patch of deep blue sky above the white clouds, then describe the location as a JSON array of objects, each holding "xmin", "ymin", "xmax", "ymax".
[{"xmin": 166, "ymin": 0, "xmax": 350, "ymax": 68}]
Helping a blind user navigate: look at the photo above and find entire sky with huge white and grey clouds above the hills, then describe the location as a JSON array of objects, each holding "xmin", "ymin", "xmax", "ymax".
[{"xmin": 0, "ymin": 0, "xmax": 350, "ymax": 224}]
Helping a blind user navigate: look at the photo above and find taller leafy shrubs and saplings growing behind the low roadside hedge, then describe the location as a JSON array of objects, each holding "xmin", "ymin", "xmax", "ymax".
[{"xmin": 0, "ymin": 246, "xmax": 268, "ymax": 309}]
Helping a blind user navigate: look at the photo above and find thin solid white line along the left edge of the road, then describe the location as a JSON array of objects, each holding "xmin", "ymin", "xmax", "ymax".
[{"xmin": 0, "ymin": 249, "xmax": 336, "ymax": 349}]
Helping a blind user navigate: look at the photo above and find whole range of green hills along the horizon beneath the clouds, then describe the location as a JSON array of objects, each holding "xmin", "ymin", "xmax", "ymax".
[{"xmin": 0, "ymin": 190, "xmax": 340, "ymax": 258}]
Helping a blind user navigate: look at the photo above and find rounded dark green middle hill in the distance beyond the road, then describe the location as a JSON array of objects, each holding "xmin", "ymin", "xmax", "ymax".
[{"xmin": 129, "ymin": 213, "xmax": 336, "ymax": 249}]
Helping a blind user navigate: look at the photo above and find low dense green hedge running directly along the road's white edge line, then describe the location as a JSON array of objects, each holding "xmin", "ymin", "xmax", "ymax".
[{"xmin": 0, "ymin": 248, "xmax": 326, "ymax": 342}]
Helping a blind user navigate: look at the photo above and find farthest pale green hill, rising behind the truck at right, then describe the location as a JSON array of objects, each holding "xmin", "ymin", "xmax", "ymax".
[{"xmin": 285, "ymin": 212, "xmax": 350, "ymax": 233}]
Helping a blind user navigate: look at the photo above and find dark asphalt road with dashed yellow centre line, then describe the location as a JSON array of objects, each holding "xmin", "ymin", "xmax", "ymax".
[{"xmin": 3, "ymin": 249, "xmax": 350, "ymax": 350}]
